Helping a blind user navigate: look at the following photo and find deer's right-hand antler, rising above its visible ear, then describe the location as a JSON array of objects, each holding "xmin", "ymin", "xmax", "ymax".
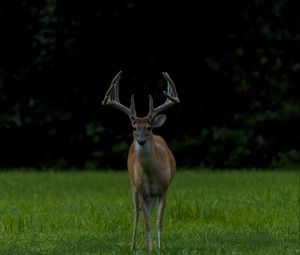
[{"xmin": 147, "ymin": 72, "xmax": 179, "ymax": 120}]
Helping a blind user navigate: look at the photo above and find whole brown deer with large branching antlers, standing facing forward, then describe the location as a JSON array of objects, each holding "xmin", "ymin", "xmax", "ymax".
[{"xmin": 102, "ymin": 71, "xmax": 179, "ymax": 253}]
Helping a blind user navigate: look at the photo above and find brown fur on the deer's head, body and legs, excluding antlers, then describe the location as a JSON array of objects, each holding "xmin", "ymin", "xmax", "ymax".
[{"xmin": 127, "ymin": 125, "xmax": 176, "ymax": 251}]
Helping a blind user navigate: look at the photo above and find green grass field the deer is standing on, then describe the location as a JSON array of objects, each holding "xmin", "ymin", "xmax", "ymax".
[{"xmin": 0, "ymin": 169, "xmax": 300, "ymax": 255}]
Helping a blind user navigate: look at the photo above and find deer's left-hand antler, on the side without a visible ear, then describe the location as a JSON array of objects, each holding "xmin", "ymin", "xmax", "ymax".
[{"xmin": 102, "ymin": 71, "xmax": 136, "ymax": 118}]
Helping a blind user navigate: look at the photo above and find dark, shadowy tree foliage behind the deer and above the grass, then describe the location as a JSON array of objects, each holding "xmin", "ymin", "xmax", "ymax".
[{"xmin": 0, "ymin": 0, "xmax": 300, "ymax": 169}]
